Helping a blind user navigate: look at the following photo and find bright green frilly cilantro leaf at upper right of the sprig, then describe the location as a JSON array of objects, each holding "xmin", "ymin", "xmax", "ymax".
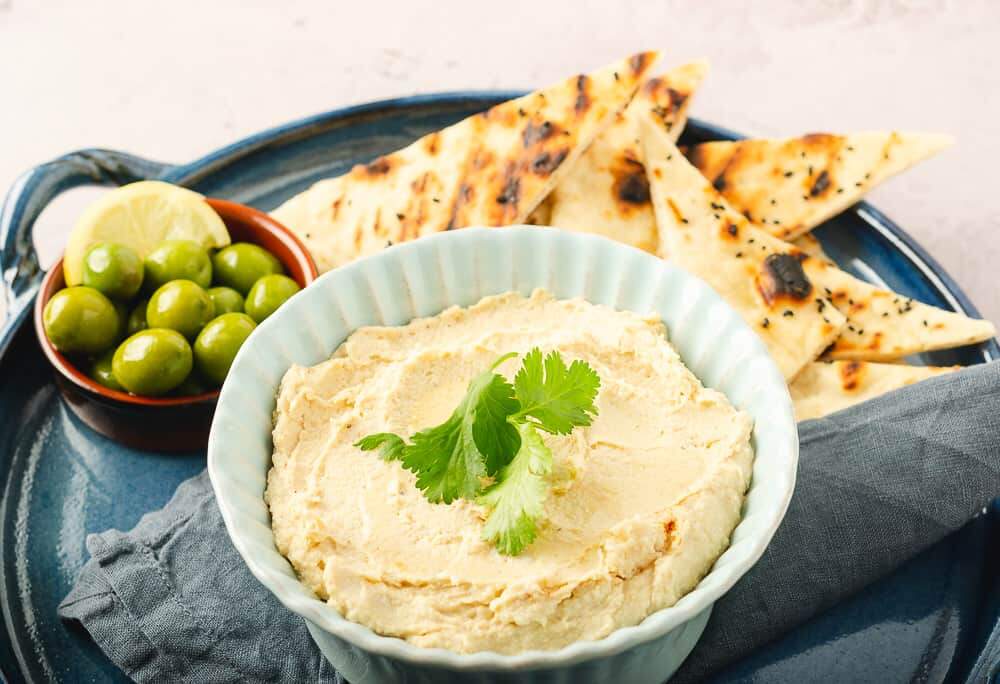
[{"xmin": 512, "ymin": 347, "xmax": 601, "ymax": 435}]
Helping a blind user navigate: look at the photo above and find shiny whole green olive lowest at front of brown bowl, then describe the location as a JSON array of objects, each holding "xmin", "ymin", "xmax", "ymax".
[{"xmin": 111, "ymin": 328, "xmax": 193, "ymax": 397}]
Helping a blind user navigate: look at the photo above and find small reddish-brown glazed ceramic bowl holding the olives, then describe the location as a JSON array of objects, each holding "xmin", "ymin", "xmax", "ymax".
[{"xmin": 35, "ymin": 198, "xmax": 317, "ymax": 451}]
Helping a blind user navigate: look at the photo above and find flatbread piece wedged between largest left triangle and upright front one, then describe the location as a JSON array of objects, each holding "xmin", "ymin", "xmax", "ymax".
[{"xmin": 545, "ymin": 61, "xmax": 708, "ymax": 252}]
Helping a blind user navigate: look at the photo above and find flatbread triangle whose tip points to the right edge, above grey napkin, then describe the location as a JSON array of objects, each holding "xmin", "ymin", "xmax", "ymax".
[{"xmin": 802, "ymin": 257, "xmax": 996, "ymax": 361}]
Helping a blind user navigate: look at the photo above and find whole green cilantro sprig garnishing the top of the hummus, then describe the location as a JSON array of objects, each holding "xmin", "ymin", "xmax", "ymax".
[{"xmin": 355, "ymin": 347, "xmax": 601, "ymax": 556}]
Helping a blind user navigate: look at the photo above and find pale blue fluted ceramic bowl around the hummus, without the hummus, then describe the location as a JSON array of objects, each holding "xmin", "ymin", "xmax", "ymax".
[{"xmin": 208, "ymin": 227, "xmax": 798, "ymax": 684}]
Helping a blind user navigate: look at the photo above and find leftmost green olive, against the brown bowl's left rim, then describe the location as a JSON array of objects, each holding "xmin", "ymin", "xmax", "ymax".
[{"xmin": 42, "ymin": 285, "xmax": 119, "ymax": 354}]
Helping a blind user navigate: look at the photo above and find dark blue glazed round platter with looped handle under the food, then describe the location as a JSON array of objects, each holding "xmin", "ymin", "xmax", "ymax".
[{"xmin": 0, "ymin": 92, "xmax": 1000, "ymax": 682}]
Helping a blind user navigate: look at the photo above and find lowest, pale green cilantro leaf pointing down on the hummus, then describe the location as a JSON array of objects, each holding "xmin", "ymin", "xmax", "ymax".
[{"xmin": 477, "ymin": 423, "xmax": 552, "ymax": 556}]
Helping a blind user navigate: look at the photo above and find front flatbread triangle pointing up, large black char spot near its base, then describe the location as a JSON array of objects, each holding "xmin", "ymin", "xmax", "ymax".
[{"xmin": 641, "ymin": 117, "xmax": 844, "ymax": 379}]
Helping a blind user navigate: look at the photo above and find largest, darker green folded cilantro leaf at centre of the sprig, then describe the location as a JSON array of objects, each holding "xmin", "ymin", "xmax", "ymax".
[{"xmin": 402, "ymin": 370, "xmax": 519, "ymax": 503}]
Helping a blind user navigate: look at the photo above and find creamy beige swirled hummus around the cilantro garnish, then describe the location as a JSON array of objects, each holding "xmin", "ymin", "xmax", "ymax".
[{"xmin": 265, "ymin": 291, "xmax": 753, "ymax": 653}]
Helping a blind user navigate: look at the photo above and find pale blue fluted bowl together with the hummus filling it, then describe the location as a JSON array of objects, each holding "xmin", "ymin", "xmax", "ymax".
[{"xmin": 208, "ymin": 227, "xmax": 798, "ymax": 684}]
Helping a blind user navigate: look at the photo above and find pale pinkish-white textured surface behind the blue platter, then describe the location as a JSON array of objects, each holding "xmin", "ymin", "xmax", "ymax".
[{"xmin": 0, "ymin": 0, "xmax": 1000, "ymax": 330}]
